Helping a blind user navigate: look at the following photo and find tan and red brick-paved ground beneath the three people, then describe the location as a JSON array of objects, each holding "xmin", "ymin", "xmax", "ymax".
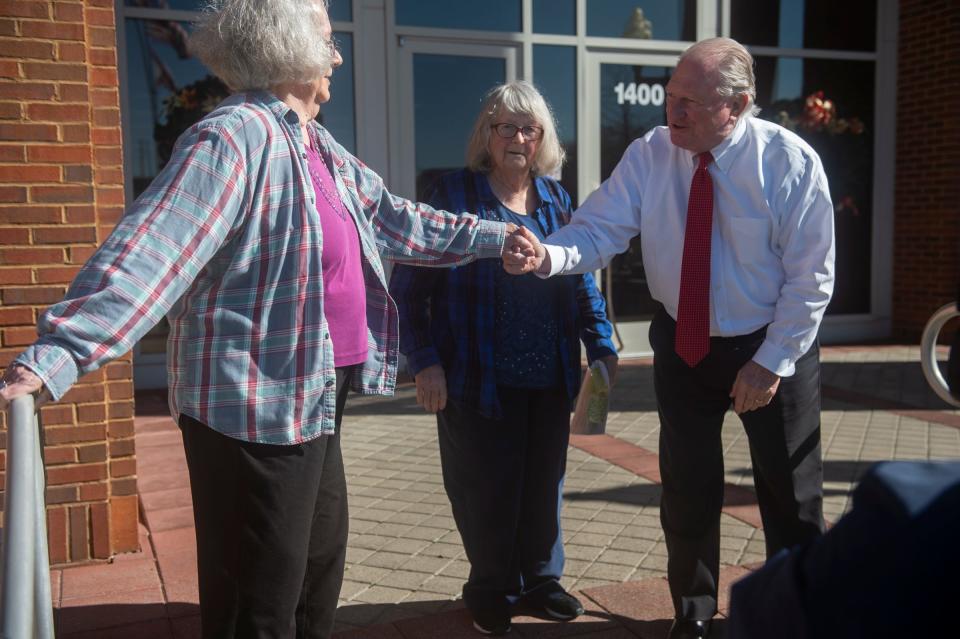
[{"xmin": 51, "ymin": 346, "xmax": 960, "ymax": 639}]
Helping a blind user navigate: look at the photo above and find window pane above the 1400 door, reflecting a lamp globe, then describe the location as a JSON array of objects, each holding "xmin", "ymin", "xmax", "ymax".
[{"xmin": 587, "ymin": 0, "xmax": 697, "ymax": 41}]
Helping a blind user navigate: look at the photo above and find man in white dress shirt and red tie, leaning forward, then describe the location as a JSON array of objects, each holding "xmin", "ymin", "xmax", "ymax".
[{"xmin": 507, "ymin": 38, "xmax": 834, "ymax": 639}]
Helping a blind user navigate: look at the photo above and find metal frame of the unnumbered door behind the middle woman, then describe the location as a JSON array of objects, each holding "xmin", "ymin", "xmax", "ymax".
[{"xmin": 393, "ymin": 36, "xmax": 521, "ymax": 198}]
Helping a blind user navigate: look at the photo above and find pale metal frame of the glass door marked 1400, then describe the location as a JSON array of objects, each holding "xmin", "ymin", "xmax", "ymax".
[{"xmin": 577, "ymin": 48, "xmax": 677, "ymax": 357}]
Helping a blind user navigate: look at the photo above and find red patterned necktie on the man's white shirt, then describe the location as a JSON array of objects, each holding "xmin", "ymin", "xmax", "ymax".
[{"xmin": 673, "ymin": 153, "xmax": 713, "ymax": 368}]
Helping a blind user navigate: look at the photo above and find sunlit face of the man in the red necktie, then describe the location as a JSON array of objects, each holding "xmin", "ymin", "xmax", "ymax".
[{"xmin": 667, "ymin": 58, "xmax": 746, "ymax": 153}]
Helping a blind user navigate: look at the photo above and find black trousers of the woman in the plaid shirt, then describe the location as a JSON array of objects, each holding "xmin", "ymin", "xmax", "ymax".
[{"xmin": 180, "ymin": 367, "xmax": 354, "ymax": 639}]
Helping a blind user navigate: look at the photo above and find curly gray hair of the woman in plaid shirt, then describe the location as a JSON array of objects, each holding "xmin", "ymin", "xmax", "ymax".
[{"xmin": 190, "ymin": 0, "xmax": 333, "ymax": 91}]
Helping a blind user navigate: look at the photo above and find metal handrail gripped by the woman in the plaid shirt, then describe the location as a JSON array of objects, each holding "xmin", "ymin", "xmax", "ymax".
[{"xmin": 0, "ymin": 395, "xmax": 53, "ymax": 639}]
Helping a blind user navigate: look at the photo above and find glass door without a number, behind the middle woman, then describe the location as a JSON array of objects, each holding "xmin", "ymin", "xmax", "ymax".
[{"xmin": 397, "ymin": 37, "xmax": 518, "ymax": 199}]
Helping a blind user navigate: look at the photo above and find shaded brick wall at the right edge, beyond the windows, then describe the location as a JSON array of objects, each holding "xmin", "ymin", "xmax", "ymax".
[{"xmin": 881, "ymin": 0, "xmax": 960, "ymax": 342}]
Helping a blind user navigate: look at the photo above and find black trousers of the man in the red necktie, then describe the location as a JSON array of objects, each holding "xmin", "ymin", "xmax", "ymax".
[{"xmin": 650, "ymin": 309, "xmax": 824, "ymax": 619}]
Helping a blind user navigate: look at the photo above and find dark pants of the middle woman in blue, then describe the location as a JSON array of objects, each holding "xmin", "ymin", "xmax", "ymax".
[{"xmin": 437, "ymin": 387, "xmax": 570, "ymax": 613}]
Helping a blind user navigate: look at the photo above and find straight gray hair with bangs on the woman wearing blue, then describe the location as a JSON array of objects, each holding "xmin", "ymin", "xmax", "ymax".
[{"xmin": 467, "ymin": 80, "xmax": 566, "ymax": 177}]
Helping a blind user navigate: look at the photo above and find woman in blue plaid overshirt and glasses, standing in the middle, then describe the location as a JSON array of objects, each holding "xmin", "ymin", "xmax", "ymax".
[{"xmin": 390, "ymin": 82, "xmax": 617, "ymax": 635}]
